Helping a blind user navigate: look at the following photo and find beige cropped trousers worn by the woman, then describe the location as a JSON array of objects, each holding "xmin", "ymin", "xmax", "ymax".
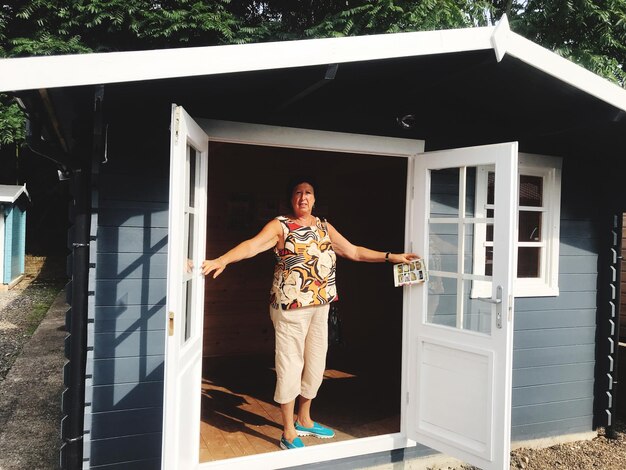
[{"xmin": 270, "ymin": 304, "xmax": 330, "ymax": 404}]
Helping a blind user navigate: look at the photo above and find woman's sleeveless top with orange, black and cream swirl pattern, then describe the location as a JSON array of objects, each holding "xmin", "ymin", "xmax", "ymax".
[{"xmin": 270, "ymin": 216, "xmax": 338, "ymax": 310}]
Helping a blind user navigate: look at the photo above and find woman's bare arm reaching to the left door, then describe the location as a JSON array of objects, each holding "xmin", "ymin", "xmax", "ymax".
[{"xmin": 202, "ymin": 219, "xmax": 282, "ymax": 279}]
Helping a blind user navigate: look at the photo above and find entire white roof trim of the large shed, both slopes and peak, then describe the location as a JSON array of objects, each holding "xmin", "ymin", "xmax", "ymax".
[{"xmin": 0, "ymin": 16, "xmax": 626, "ymax": 111}]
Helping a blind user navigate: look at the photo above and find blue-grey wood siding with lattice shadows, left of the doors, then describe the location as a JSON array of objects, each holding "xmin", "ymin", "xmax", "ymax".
[{"xmin": 85, "ymin": 125, "xmax": 168, "ymax": 470}]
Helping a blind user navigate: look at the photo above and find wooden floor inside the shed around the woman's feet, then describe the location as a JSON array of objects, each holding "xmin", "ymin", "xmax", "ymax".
[{"xmin": 200, "ymin": 357, "xmax": 400, "ymax": 462}]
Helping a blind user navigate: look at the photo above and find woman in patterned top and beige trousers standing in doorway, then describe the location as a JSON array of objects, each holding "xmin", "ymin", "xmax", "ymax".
[{"xmin": 202, "ymin": 177, "xmax": 418, "ymax": 449}]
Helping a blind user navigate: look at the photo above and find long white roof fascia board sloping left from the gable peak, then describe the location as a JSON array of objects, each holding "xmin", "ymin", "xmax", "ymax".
[{"xmin": 0, "ymin": 26, "xmax": 494, "ymax": 92}]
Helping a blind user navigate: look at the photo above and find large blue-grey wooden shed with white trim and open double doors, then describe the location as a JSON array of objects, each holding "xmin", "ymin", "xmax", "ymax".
[{"xmin": 0, "ymin": 18, "xmax": 626, "ymax": 470}]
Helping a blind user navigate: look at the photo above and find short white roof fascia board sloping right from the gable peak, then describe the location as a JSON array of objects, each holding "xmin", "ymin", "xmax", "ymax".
[{"xmin": 506, "ymin": 32, "xmax": 626, "ymax": 111}]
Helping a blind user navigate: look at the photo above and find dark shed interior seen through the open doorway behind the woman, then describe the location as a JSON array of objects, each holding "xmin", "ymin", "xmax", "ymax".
[{"xmin": 201, "ymin": 142, "xmax": 407, "ymax": 461}]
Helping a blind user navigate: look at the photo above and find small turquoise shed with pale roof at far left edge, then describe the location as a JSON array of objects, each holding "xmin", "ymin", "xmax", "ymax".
[{"xmin": 0, "ymin": 184, "xmax": 28, "ymax": 290}]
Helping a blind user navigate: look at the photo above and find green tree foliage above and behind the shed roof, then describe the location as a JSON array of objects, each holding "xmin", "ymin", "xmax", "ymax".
[{"xmin": 0, "ymin": 0, "xmax": 626, "ymax": 145}]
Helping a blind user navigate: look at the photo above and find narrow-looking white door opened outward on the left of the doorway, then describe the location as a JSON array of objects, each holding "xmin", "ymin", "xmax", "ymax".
[{"xmin": 162, "ymin": 105, "xmax": 209, "ymax": 470}]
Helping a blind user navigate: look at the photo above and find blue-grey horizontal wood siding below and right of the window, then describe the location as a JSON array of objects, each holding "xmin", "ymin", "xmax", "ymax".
[{"xmin": 511, "ymin": 160, "xmax": 599, "ymax": 440}]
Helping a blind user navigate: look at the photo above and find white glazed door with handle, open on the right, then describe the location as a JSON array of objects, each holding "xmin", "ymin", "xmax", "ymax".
[{"xmin": 406, "ymin": 143, "xmax": 518, "ymax": 470}]
